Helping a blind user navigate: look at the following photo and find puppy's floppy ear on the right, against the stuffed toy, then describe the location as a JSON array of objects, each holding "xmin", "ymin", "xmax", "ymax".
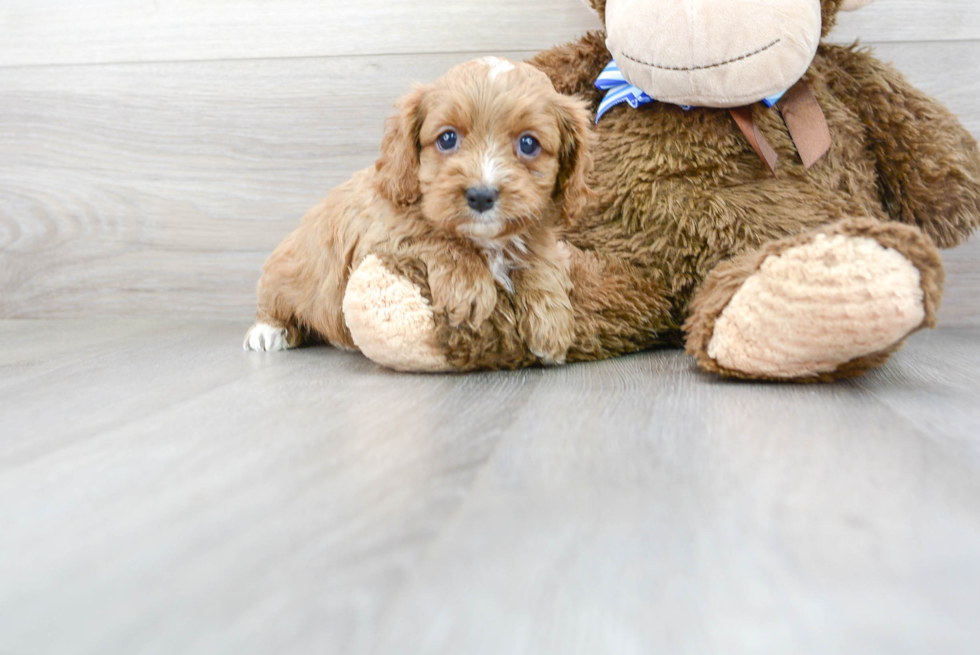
[{"xmin": 553, "ymin": 95, "xmax": 593, "ymax": 222}]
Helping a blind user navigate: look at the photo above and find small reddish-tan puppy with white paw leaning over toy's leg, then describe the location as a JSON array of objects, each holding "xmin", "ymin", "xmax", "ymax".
[{"xmin": 245, "ymin": 57, "xmax": 592, "ymax": 363}]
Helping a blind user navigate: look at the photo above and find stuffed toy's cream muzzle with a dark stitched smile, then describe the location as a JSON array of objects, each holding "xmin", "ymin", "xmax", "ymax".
[{"xmin": 605, "ymin": 0, "xmax": 823, "ymax": 108}]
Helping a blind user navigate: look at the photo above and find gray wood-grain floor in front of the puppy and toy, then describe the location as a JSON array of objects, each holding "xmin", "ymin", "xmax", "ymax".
[{"xmin": 0, "ymin": 319, "xmax": 980, "ymax": 655}]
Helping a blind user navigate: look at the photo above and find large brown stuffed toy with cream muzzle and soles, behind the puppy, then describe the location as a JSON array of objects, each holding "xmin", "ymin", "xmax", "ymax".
[{"xmin": 343, "ymin": 0, "xmax": 980, "ymax": 381}]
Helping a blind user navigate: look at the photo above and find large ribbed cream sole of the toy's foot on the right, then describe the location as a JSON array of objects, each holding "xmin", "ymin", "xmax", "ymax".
[{"xmin": 708, "ymin": 234, "xmax": 926, "ymax": 379}]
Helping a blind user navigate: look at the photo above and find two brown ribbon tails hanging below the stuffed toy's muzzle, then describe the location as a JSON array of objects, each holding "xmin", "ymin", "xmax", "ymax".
[{"xmin": 729, "ymin": 80, "xmax": 832, "ymax": 176}]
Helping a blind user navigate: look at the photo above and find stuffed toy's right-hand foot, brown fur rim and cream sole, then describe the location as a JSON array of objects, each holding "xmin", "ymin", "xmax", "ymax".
[{"xmin": 684, "ymin": 219, "xmax": 944, "ymax": 381}]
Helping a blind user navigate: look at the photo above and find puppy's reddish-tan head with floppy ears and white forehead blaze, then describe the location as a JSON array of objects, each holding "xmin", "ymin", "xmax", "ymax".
[{"xmin": 377, "ymin": 57, "xmax": 591, "ymax": 242}]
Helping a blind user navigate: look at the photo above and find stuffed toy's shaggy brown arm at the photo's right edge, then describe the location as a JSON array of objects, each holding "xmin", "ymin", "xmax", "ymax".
[{"xmin": 820, "ymin": 46, "xmax": 980, "ymax": 248}]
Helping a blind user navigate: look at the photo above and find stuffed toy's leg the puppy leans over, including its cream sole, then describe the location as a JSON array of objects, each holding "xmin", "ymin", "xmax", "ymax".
[{"xmin": 344, "ymin": 245, "xmax": 680, "ymax": 372}]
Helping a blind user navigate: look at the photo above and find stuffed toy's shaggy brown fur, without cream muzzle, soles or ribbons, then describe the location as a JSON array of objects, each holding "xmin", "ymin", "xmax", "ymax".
[{"xmin": 338, "ymin": 0, "xmax": 980, "ymax": 380}]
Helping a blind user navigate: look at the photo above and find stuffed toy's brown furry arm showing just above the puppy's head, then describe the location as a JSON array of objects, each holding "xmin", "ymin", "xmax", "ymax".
[{"xmin": 527, "ymin": 32, "xmax": 612, "ymax": 107}]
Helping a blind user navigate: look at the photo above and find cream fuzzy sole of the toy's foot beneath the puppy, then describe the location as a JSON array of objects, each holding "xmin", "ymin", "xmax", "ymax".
[{"xmin": 344, "ymin": 255, "xmax": 449, "ymax": 372}]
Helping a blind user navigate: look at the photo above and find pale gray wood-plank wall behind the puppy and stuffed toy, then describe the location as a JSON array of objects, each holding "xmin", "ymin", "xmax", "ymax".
[{"xmin": 0, "ymin": 0, "xmax": 980, "ymax": 325}]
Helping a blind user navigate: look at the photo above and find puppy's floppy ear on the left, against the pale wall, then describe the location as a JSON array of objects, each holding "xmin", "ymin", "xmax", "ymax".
[{"xmin": 374, "ymin": 87, "xmax": 426, "ymax": 205}]
